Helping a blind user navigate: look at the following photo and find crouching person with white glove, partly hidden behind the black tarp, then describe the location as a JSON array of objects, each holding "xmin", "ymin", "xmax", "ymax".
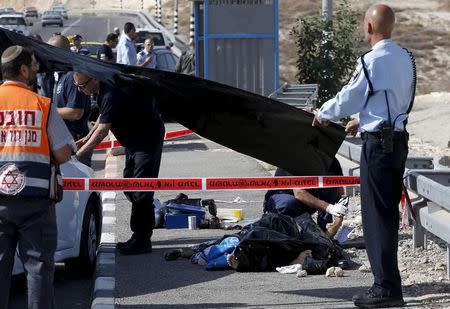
[{"xmin": 264, "ymin": 159, "xmax": 348, "ymax": 238}]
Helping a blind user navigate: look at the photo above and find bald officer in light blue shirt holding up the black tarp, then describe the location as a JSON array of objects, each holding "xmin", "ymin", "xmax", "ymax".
[{"xmin": 313, "ymin": 4, "xmax": 415, "ymax": 308}]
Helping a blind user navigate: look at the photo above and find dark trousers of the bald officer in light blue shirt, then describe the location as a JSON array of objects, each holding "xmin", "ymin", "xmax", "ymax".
[{"xmin": 360, "ymin": 133, "xmax": 408, "ymax": 297}]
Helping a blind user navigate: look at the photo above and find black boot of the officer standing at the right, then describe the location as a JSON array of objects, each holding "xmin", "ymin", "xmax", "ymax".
[{"xmin": 353, "ymin": 286, "xmax": 405, "ymax": 308}]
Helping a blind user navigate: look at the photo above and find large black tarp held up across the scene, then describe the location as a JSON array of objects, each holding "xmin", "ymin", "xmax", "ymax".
[{"xmin": 0, "ymin": 29, "xmax": 345, "ymax": 176}]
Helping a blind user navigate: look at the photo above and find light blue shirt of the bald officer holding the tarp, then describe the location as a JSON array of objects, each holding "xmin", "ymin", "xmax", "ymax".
[{"xmin": 318, "ymin": 39, "xmax": 414, "ymax": 132}]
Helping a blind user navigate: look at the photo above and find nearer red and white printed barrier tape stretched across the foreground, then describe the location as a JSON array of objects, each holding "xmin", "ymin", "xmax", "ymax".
[{"xmin": 63, "ymin": 176, "xmax": 359, "ymax": 191}]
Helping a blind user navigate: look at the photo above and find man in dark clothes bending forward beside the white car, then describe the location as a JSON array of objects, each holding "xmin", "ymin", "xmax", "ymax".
[{"xmin": 73, "ymin": 72, "xmax": 165, "ymax": 255}]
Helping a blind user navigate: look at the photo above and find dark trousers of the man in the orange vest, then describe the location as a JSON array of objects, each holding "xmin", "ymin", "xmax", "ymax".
[{"xmin": 0, "ymin": 198, "xmax": 58, "ymax": 309}]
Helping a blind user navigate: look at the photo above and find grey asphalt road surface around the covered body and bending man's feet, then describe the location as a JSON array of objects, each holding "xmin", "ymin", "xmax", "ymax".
[{"xmin": 115, "ymin": 124, "xmax": 372, "ymax": 309}]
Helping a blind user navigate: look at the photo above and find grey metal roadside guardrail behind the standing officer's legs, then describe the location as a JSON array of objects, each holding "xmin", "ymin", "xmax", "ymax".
[{"xmin": 338, "ymin": 137, "xmax": 450, "ymax": 278}]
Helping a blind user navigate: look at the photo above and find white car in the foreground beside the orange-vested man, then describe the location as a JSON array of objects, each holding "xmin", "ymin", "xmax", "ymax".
[{"xmin": 13, "ymin": 160, "xmax": 103, "ymax": 277}]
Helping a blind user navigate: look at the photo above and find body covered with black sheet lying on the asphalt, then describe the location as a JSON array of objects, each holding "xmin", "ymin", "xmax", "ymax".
[{"xmin": 233, "ymin": 213, "xmax": 342, "ymax": 272}]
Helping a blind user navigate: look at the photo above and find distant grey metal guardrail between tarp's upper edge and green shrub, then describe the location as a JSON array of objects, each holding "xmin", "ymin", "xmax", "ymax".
[{"xmin": 269, "ymin": 83, "xmax": 319, "ymax": 110}]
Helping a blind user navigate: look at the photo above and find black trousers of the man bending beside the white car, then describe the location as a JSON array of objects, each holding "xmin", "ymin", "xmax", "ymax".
[{"xmin": 123, "ymin": 138, "xmax": 163, "ymax": 239}]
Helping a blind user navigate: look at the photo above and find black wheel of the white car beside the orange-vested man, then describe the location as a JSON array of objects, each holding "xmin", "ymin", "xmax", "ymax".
[{"xmin": 65, "ymin": 199, "xmax": 100, "ymax": 278}]
